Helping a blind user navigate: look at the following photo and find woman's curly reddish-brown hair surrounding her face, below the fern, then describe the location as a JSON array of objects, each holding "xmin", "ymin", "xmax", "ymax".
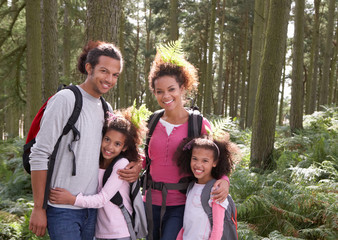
[{"xmin": 148, "ymin": 51, "xmax": 198, "ymax": 91}]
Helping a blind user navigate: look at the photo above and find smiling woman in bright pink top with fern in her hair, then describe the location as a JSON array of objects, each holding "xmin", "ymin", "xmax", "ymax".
[{"xmin": 145, "ymin": 42, "xmax": 229, "ymax": 240}]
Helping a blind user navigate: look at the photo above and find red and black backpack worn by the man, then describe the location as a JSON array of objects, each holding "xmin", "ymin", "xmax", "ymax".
[{"xmin": 22, "ymin": 85, "xmax": 109, "ymax": 209}]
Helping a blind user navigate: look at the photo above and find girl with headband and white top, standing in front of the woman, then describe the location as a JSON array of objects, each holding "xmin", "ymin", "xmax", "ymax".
[{"xmin": 175, "ymin": 136, "xmax": 233, "ymax": 240}]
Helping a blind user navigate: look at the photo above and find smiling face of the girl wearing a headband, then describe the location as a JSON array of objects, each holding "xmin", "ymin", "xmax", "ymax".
[{"xmin": 190, "ymin": 147, "xmax": 217, "ymax": 184}]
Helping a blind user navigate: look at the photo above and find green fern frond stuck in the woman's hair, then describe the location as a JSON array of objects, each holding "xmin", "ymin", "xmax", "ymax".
[{"xmin": 157, "ymin": 40, "xmax": 186, "ymax": 67}]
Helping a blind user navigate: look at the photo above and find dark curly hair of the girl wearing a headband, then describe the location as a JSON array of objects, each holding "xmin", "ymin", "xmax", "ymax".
[{"xmin": 174, "ymin": 135, "xmax": 234, "ymax": 179}]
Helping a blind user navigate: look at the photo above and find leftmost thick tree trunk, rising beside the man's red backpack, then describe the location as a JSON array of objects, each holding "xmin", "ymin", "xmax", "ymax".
[{"xmin": 25, "ymin": 0, "xmax": 42, "ymax": 133}]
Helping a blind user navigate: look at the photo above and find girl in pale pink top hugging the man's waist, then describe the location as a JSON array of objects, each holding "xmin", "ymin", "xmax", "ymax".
[{"xmin": 49, "ymin": 108, "xmax": 143, "ymax": 240}]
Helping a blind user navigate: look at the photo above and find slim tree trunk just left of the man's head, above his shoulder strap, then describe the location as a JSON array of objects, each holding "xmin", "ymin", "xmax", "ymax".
[{"xmin": 62, "ymin": 0, "xmax": 71, "ymax": 84}]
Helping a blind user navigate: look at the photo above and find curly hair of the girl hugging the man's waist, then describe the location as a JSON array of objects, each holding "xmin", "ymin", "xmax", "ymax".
[{"xmin": 100, "ymin": 107, "xmax": 145, "ymax": 167}]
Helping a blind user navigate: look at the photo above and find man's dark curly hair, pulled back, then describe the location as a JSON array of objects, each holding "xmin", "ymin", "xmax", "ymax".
[{"xmin": 77, "ymin": 41, "xmax": 123, "ymax": 75}]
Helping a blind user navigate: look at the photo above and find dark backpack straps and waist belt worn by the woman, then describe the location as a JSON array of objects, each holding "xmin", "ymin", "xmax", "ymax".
[{"xmin": 142, "ymin": 108, "xmax": 203, "ymax": 240}]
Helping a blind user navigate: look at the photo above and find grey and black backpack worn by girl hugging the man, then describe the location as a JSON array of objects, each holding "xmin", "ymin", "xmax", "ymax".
[{"xmin": 102, "ymin": 155, "xmax": 148, "ymax": 240}]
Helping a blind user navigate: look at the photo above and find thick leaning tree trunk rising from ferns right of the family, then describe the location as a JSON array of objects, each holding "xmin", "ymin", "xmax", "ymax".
[{"xmin": 250, "ymin": 0, "xmax": 291, "ymax": 169}]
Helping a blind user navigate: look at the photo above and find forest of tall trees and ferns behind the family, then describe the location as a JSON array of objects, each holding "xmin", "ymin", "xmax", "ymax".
[{"xmin": 0, "ymin": 0, "xmax": 338, "ymax": 239}]
